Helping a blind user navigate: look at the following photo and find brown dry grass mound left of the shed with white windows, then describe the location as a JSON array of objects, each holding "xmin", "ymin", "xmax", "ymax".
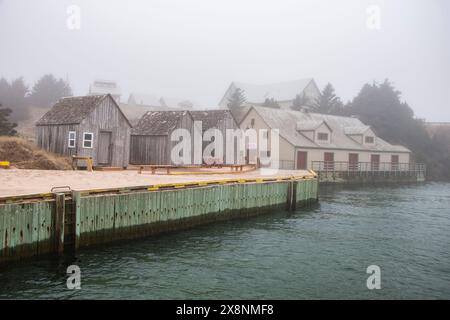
[{"xmin": 0, "ymin": 136, "xmax": 71, "ymax": 170}]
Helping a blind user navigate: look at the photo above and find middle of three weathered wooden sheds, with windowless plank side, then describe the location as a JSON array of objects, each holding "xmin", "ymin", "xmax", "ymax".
[{"xmin": 130, "ymin": 111, "xmax": 194, "ymax": 165}]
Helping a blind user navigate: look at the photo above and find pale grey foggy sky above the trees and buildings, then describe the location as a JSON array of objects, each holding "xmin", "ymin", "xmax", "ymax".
[{"xmin": 0, "ymin": 0, "xmax": 450, "ymax": 121}]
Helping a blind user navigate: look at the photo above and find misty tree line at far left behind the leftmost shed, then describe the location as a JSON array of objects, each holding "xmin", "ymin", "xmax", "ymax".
[{"xmin": 0, "ymin": 74, "xmax": 72, "ymax": 131}]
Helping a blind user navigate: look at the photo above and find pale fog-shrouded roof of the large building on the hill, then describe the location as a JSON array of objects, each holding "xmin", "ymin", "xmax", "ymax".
[{"xmin": 221, "ymin": 78, "xmax": 314, "ymax": 104}]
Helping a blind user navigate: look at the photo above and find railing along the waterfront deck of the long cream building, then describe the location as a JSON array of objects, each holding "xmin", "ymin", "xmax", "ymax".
[{"xmin": 312, "ymin": 161, "xmax": 426, "ymax": 174}]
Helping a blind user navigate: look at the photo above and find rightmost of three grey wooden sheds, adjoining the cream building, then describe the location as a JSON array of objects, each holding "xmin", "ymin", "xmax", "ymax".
[{"xmin": 190, "ymin": 109, "xmax": 240, "ymax": 164}]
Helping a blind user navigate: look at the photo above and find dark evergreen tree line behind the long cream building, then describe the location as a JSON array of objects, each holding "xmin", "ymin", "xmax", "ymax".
[{"xmin": 228, "ymin": 79, "xmax": 450, "ymax": 180}]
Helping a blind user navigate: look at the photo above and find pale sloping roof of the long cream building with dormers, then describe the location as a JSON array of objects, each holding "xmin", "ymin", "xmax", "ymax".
[{"xmin": 247, "ymin": 107, "xmax": 410, "ymax": 152}]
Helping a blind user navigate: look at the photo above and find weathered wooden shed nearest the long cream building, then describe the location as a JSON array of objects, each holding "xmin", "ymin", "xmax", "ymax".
[{"xmin": 190, "ymin": 109, "xmax": 243, "ymax": 164}]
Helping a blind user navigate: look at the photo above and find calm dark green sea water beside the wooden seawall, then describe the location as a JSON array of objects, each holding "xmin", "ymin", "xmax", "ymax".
[{"xmin": 0, "ymin": 183, "xmax": 450, "ymax": 299}]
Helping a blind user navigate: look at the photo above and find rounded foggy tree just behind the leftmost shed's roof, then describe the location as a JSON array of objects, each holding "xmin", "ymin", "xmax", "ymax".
[{"xmin": 29, "ymin": 74, "xmax": 72, "ymax": 107}]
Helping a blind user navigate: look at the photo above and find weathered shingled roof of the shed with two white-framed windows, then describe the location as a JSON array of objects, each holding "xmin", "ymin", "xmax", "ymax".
[{"xmin": 36, "ymin": 94, "xmax": 131, "ymax": 127}]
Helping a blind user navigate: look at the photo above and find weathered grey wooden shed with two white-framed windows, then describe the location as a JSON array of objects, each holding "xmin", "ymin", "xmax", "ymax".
[{"xmin": 36, "ymin": 94, "xmax": 131, "ymax": 167}]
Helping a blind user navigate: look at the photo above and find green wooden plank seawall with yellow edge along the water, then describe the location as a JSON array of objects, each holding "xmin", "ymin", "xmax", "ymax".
[{"xmin": 0, "ymin": 177, "xmax": 318, "ymax": 263}]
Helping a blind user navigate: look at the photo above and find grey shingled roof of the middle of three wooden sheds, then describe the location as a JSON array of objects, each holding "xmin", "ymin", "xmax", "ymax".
[{"xmin": 132, "ymin": 111, "xmax": 191, "ymax": 136}]
